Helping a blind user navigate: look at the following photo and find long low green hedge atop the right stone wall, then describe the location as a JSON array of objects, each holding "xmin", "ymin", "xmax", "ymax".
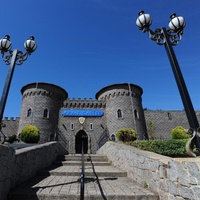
[{"xmin": 126, "ymin": 139, "xmax": 188, "ymax": 157}]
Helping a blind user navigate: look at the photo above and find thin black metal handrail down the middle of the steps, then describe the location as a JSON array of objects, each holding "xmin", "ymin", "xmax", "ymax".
[{"xmin": 80, "ymin": 136, "xmax": 85, "ymax": 200}]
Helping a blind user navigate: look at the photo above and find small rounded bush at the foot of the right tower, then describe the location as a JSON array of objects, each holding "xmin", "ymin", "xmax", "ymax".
[{"xmin": 116, "ymin": 128, "xmax": 137, "ymax": 142}]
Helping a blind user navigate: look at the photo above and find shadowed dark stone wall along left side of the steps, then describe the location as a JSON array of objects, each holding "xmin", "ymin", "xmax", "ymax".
[{"xmin": 0, "ymin": 142, "xmax": 64, "ymax": 200}]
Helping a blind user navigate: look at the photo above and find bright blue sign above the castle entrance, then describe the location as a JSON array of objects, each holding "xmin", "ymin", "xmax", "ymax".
[{"xmin": 62, "ymin": 110, "xmax": 104, "ymax": 117}]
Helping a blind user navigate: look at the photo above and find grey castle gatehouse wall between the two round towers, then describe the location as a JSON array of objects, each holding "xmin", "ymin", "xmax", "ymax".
[{"xmin": 57, "ymin": 98, "xmax": 108, "ymax": 153}]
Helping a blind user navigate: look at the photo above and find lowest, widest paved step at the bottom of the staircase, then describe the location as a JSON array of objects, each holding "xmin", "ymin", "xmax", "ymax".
[{"xmin": 8, "ymin": 175, "xmax": 159, "ymax": 200}]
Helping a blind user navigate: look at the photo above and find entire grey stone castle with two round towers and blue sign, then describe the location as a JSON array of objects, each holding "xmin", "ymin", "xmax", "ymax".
[{"xmin": 3, "ymin": 82, "xmax": 200, "ymax": 153}]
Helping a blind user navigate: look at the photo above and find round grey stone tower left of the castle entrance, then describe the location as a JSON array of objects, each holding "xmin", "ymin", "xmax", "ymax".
[{"xmin": 18, "ymin": 82, "xmax": 68, "ymax": 143}]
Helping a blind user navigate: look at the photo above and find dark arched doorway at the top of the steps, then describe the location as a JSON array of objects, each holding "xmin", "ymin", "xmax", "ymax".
[{"xmin": 75, "ymin": 130, "xmax": 88, "ymax": 154}]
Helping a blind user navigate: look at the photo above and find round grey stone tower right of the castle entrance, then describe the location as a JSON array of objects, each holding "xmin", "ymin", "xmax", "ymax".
[{"xmin": 96, "ymin": 83, "xmax": 148, "ymax": 139}]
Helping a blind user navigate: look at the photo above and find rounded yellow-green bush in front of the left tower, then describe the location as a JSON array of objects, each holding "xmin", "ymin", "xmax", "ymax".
[{"xmin": 20, "ymin": 125, "xmax": 40, "ymax": 143}]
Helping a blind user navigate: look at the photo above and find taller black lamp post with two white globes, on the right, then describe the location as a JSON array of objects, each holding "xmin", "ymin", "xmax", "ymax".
[{"xmin": 136, "ymin": 11, "xmax": 200, "ymax": 157}]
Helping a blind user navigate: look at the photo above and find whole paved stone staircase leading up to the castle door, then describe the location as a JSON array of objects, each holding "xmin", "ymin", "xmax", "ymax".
[{"xmin": 8, "ymin": 155, "xmax": 159, "ymax": 200}]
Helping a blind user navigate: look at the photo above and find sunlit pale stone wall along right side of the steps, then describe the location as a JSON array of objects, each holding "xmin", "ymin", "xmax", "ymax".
[{"xmin": 97, "ymin": 142, "xmax": 200, "ymax": 200}]
